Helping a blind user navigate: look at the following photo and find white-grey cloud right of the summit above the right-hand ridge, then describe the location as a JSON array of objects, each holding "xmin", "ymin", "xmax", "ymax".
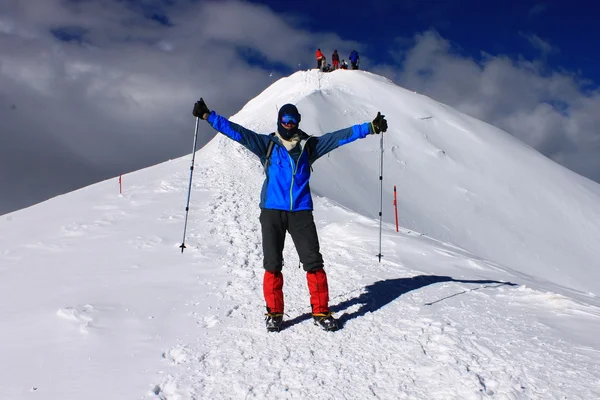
[{"xmin": 376, "ymin": 31, "xmax": 600, "ymax": 181}]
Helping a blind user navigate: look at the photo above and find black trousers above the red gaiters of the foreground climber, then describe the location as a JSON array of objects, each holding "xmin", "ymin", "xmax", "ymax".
[{"xmin": 260, "ymin": 209, "xmax": 323, "ymax": 272}]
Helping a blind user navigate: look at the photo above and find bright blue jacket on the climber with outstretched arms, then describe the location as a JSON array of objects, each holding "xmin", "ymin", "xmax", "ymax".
[{"xmin": 207, "ymin": 111, "xmax": 374, "ymax": 211}]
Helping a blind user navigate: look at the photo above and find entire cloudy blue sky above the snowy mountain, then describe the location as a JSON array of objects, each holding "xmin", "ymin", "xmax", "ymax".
[{"xmin": 0, "ymin": 0, "xmax": 600, "ymax": 214}]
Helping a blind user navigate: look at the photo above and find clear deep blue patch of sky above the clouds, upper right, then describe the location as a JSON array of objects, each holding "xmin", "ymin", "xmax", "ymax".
[{"xmin": 253, "ymin": 0, "xmax": 600, "ymax": 83}]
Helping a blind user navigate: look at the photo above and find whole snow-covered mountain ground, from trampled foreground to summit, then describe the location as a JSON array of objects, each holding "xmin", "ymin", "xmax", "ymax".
[{"xmin": 0, "ymin": 71, "xmax": 600, "ymax": 400}]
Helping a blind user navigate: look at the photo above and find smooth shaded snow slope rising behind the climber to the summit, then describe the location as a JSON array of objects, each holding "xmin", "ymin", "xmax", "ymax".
[{"xmin": 236, "ymin": 71, "xmax": 600, "ymax": 305}]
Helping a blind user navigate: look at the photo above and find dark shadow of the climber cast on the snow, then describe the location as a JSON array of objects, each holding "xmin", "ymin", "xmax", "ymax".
[{"xmin": 285, "ymin": 275, "xmax": 517, "ymax": 328}]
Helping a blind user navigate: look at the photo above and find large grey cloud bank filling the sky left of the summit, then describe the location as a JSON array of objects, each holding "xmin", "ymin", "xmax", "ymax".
[{"xmin": 0, "ymin": 0, "xmax": 360, "ymax": 213}]
